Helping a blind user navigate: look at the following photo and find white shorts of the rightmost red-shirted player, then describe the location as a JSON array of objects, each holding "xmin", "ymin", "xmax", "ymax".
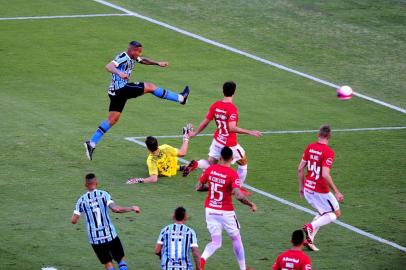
[{"xmin": 304, "ymin": 188, "xmax": 340, "ymax": 215}]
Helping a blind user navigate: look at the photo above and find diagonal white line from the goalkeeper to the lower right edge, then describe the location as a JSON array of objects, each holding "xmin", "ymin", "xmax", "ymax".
[{"xmin": 125, "ymin": 137, "xmax": 406, "ymax": 252}]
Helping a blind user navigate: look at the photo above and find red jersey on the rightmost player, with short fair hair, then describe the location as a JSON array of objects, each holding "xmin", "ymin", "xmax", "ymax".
[{"xmin": 302, "ymin": 142, "xmax": 334, "ymax": 193}]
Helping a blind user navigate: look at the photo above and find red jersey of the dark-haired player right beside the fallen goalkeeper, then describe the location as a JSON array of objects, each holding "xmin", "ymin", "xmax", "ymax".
[{"xmin": 206, "ymin": 100, "xmax": 238, "ymax": 147}]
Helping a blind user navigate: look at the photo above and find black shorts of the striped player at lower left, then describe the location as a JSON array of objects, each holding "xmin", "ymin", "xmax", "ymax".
[{"xmin": 92, "ymin": 236, "xmax": 124, "ymax": 264}]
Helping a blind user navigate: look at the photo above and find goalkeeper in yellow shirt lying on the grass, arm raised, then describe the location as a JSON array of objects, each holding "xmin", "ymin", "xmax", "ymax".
[{"xmin": 127, "ymin": 124, "xmax": 193, "ymax": 184}]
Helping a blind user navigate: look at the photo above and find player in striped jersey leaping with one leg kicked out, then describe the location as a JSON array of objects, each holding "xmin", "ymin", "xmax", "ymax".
[{"xmin": 84, "ymin": 41, "xmax": 190, "ymax": 160}]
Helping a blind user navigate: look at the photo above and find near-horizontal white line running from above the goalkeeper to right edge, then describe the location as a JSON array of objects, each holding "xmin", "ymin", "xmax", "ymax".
[{"xmin": 125, "ymin": 127, "xmax": 406, "ymax": 139}]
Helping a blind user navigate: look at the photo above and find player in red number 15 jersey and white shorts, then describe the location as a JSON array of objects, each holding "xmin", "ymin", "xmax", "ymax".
[{"xmin": 197, "ymin": 146, "xmax": 257, "ymax": 270}]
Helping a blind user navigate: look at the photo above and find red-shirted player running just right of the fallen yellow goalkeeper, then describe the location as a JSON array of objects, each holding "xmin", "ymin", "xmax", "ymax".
[{"xmin": 183, "ymin": 81, "xmax": 262, "ymax": 193}]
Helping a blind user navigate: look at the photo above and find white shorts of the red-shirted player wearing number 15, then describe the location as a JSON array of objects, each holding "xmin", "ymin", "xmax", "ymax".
[{"xmin": 206, "ymin": 208, "xmax": 240, "ymax": 237}]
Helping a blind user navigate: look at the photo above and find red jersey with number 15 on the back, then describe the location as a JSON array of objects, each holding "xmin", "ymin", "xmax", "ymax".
[{"xmin": 199, "ymin": 164, "xmax": 241, "ymax": 211}]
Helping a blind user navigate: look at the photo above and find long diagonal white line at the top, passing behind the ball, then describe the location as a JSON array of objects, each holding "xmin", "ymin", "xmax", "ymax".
[{"xmin": 93, "ymin": 0, "xmax": 406, "ymax": 113}]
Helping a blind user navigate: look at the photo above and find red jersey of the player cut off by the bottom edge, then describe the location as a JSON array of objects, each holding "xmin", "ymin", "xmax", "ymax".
[{"xmin": 272, "ymin": 249, "xmax": 312, "ymax": 270}]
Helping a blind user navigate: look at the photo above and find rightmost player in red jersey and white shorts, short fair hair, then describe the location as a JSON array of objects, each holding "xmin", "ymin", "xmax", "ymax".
[{"xmin": 297, "ymin": 125, "xmax": 344, "ymax": 251}]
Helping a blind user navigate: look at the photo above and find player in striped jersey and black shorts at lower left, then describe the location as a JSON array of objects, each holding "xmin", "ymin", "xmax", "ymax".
[{"xmin": 71, "ymin": 173, "xmax": 140, "ymax": 270}]
